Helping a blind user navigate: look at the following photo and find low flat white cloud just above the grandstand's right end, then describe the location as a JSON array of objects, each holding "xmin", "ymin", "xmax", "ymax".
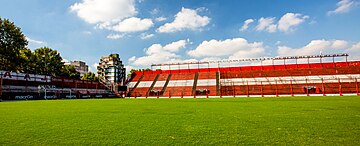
[{"xmin": 277, "ymin": 40, "xmax": 348, "ymax": 56}]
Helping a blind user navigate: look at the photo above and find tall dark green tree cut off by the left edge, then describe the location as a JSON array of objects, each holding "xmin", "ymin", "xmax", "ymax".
[{"xmin": 0, "ymin": 17, "xmax": 28, "ymax": 72}]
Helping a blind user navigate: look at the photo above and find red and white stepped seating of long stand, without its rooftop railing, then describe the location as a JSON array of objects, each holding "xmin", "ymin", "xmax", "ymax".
[{"xmin": 129, "ymin": 61, "xmax": 360, "ymax": 97}]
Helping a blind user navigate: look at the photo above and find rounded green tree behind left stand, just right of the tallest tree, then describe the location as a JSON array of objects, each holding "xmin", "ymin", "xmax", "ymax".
[{"xmin": 34, "ymin": 47, "xmax": 64, "ymax": 76}]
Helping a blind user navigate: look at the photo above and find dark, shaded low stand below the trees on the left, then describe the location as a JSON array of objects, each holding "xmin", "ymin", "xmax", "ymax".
[{"xmin": 0, "ymin": 71, "xmax": 115, "ymax": 100}]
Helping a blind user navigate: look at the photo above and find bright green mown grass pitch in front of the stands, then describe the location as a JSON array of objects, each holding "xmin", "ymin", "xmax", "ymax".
[{"xmin": 0, "ymin": 96, "xmax": 360, "ymax": 145}]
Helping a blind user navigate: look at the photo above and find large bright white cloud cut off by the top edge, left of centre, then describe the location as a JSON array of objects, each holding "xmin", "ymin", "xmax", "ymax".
[{"xmin": 70, "ymin": 0, "xmax": 137, "ymax": 24}]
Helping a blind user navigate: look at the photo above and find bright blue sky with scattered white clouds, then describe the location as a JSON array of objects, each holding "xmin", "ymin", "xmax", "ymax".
[{"xmin": 0, "ymin": 0, "xmax": 360, "ymax": 71}]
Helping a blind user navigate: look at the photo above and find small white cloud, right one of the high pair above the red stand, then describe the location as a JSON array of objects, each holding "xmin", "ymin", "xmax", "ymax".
[{"xmin": 278, "ymin": 13, "xmax": 309, "ymax": 32}]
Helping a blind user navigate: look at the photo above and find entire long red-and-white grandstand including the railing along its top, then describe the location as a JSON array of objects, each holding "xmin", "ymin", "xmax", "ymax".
[{"xmin": 127, "ymin": 54, "xmax": 360, "ymax": 98}]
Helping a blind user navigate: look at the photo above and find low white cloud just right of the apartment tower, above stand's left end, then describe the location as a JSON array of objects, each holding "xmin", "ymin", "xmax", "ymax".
[{"xmin": 129, "ymin": 40, "xmax": 189, "ymax": 66}]
